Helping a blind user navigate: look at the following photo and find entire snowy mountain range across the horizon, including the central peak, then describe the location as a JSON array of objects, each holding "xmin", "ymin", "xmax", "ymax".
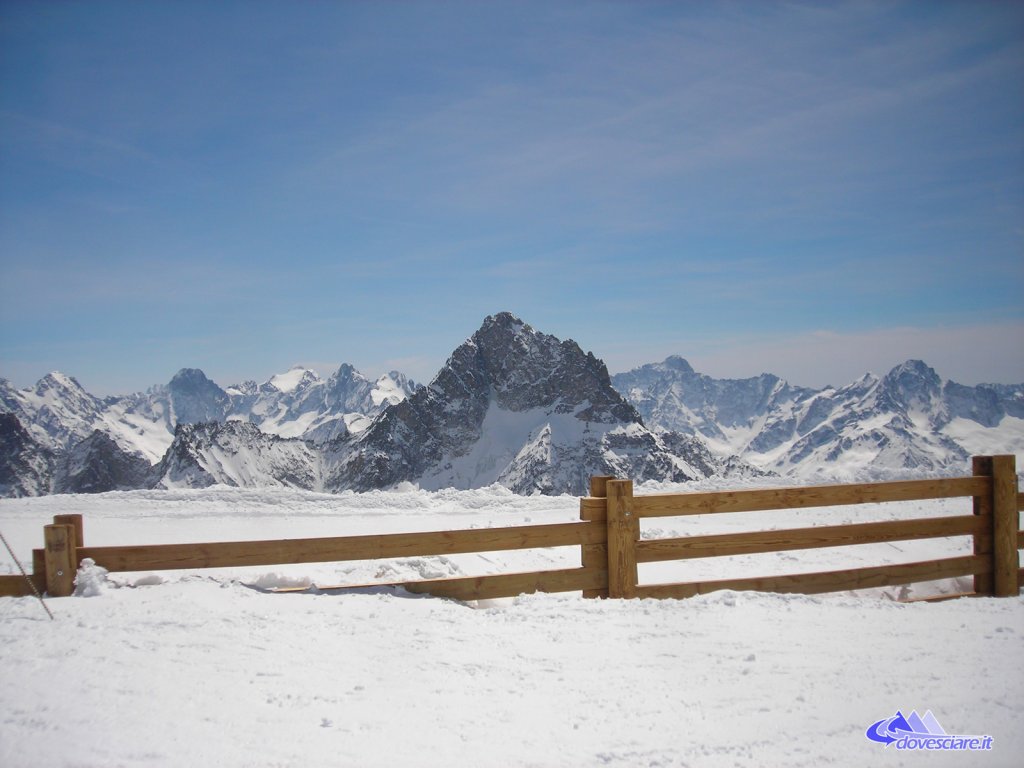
[{"xmin": 0, "ymin": 312, "xmax": 1024, "ymax": 496}]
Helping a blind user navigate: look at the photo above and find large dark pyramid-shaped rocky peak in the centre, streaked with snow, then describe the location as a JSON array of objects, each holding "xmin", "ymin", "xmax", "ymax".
[{"xmin": 327, "ymin": 312, "xmax": 720, "ymax": 494}]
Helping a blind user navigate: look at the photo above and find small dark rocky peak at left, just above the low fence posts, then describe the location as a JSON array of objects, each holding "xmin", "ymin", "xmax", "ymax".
[{"xmin": 53, "ymin": 430, "xmax": 153, "ymax": 494}]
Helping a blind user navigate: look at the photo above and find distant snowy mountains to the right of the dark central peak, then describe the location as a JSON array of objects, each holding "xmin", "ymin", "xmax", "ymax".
[{"xmin": 613, "ymin": 357, "xmax": 1024, "ymax": 479}]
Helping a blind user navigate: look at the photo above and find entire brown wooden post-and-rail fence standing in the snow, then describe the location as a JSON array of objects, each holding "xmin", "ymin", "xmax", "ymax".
[{"xmin": 0, "ymin": 456, "xmax": 1024, "ymax": 600}]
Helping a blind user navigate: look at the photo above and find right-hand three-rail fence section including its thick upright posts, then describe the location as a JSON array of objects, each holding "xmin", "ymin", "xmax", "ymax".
[{"xmin": 580, "ymin": 456, "xmax": 1024, "ymax": 598}]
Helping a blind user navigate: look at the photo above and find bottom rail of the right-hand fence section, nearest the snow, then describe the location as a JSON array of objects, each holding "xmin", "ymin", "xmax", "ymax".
[{"xmin": 637, "ymin": 555, "xmax": 992, "ymax": 598}]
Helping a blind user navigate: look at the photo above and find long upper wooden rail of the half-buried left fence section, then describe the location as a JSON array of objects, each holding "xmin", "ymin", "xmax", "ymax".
[{"xmin": 78, "ymin": 522, "xmax": 605, "ymax": 572}]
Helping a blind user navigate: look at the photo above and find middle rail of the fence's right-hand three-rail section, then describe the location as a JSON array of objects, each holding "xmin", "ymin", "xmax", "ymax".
[{"xmin": 637, "ymin": 515, "xmax": 988, "ymax": 562}]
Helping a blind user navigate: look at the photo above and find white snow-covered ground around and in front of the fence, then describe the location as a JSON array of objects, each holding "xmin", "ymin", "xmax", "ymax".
[{"xmin": 0, "ymin": 486, "xmax": 1024, "ymax": 767}]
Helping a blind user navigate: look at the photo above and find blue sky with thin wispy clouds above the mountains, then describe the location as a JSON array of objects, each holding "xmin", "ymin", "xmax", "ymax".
[{"xmin": 0, "ymin": 1, "xmax": 1024, "ymax": 393}]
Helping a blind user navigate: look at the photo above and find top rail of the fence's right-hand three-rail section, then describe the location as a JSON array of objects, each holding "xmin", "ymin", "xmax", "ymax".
[{"xmin": 634, "ymin": 477, "xmax": 992, "ymax": 517}]
